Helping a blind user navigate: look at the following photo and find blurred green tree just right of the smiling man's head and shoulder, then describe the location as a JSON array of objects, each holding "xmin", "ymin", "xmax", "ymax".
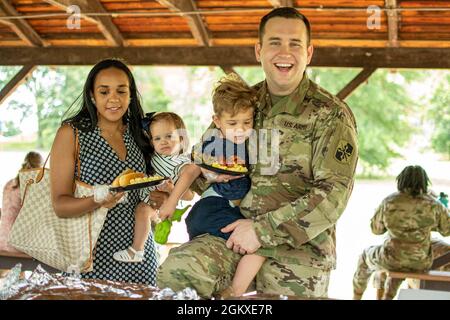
[{"xmin": 311, "ymin": 68, "xmax": 422, "ymax": 175}]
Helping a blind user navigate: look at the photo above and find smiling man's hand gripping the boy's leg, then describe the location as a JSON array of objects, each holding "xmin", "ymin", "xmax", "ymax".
[{"xmin": 221, "ymin": 219, "xmax": 261, "ymax": 254}]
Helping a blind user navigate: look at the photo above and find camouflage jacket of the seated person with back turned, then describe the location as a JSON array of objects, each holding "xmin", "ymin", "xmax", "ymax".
[{"xmin": 371, "ymin": 192, "xmax": 450, "ymax": 270}]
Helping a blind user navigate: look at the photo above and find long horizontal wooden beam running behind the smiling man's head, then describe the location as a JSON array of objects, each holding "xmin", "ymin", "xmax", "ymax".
[{"xmin": 0, "ymin": 46, "xmax": 450, "ymax": 69}]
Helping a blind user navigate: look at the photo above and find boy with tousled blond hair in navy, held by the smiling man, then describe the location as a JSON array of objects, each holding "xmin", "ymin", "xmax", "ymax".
[{"xmin": 158, "ymin": 74, "xmax": 265, "ymax": 296}]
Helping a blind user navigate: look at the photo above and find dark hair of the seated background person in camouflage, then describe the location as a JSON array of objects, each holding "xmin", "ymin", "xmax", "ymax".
[{"xmin": 397, "ymin": 166, "xmax": 431, "ymax": 197}]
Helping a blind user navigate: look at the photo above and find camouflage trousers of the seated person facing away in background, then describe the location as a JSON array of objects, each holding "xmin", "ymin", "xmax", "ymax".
[{"xmin": 353, "ymin": 240, "xmax": 450, "ymax": 300}]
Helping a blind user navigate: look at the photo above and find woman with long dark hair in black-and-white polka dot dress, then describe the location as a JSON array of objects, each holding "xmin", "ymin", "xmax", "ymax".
[{"xmin": 50, "ymin": 59, "xmax": 158, "ymax": 285}]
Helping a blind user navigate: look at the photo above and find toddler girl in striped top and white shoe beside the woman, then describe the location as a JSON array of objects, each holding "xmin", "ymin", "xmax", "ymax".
[{"xmin": 113, "ymin": 112, "xmax": 194, "ymax": 262}]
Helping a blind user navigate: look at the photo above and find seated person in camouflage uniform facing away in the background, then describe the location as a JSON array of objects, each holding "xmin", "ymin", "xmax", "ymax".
[{"xmin": 353, "ymin": 166, "xmax": 450, "ymax": 299}]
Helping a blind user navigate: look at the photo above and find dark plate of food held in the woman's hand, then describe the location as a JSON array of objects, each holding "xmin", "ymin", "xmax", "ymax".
[{"xmin": 109, "ymin": 169, "xmax": 168, "ymax": 192}]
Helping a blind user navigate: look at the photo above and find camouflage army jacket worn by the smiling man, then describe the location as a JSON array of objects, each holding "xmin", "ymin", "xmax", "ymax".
[{"xmin": 191, "ymin": 73, "xmax": 358, "ymax": 269}]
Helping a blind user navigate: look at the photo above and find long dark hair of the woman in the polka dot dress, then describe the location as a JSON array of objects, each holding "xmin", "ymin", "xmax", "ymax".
[{"xmin": 62, "ymin": 59, "xmax": 153, "ymax": 174}]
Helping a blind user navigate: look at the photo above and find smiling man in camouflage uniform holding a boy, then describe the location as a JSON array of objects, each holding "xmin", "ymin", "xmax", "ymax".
[{"xmin": 157, "ymin": 8, "xmax": 358, "ymax": 297}]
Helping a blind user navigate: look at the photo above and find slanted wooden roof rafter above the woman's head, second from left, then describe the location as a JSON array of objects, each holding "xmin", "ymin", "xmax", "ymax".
[{"xmin": 44, "ymin": 0, "xmax": 125, "ymax": 47}]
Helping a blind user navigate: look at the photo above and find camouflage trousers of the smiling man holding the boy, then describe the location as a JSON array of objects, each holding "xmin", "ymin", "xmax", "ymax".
[{"xmin": 157, "ymin": 235, "xmax": 330, "ymax": 298}]
